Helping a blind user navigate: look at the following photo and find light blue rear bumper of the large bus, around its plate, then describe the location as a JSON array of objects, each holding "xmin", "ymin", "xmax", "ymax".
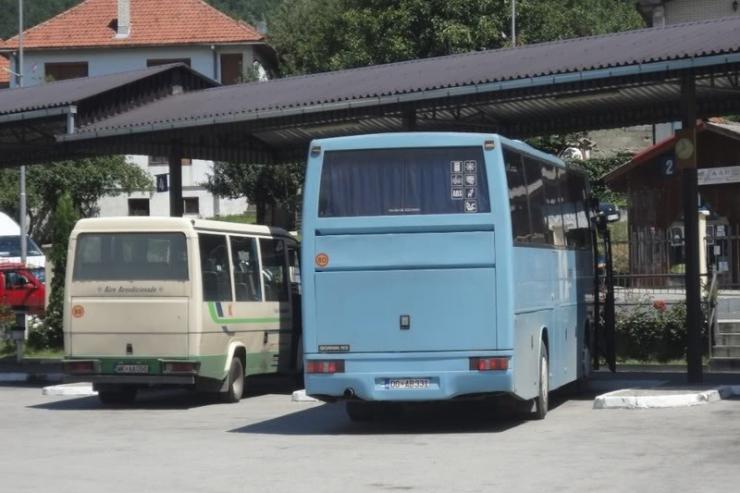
[{"xmin": 305, "ymin": 351, "xmax": 515, "ymax": 401}]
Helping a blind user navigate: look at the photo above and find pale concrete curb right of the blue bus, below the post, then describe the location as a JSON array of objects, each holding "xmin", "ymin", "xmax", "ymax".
[{"xmin": 593, "ymin": 385, "xmax": 740, "ymax": 409}]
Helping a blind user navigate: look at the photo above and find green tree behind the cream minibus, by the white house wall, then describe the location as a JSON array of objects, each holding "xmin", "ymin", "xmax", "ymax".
[{"xmin": 0, "ymin": 156, "xmax": 153, "ymax": 242}]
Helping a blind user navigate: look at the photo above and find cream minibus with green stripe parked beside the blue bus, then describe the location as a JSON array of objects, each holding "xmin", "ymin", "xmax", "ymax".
[{"xmin": 64, "ymin": 217, "xmax": 302, "ymax": 404}]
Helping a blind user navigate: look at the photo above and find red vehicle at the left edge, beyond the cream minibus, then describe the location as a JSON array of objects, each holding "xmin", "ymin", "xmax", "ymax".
[{"xmin": 0, "ymin": 262, "xmax": 46, "ymax": 315}]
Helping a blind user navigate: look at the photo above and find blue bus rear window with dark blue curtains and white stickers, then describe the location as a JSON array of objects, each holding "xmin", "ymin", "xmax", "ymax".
[{"xmin": 319, "ymin": 147, "xmax": 491, "ymax": 217}]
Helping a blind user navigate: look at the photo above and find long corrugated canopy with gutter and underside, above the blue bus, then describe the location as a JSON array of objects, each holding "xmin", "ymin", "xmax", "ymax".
[{"xmin": 0, "ymin": 17, "xmax": 740, "ymax": 165}]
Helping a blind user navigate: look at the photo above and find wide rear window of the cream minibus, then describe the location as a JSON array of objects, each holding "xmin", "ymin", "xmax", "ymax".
[{"xmin": 73, "ymin": 233, "xmax": 188, "ymax": 281}]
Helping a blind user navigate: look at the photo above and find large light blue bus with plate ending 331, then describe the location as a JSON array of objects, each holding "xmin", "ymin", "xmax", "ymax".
[{"xmin": 302, "ymin": 132, "xmax": 594, "ymax": 420}]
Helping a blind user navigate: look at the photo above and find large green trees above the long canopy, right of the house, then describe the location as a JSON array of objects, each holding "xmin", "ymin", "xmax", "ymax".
[{"xmin": 270, "ymin": 0, "xmax": 644, "ymax": 74}]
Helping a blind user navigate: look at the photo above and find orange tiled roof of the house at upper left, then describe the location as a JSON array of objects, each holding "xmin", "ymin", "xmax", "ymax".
[{"xmin": 0, "ymin": 0, "xmax": 264, "ymax": 50}]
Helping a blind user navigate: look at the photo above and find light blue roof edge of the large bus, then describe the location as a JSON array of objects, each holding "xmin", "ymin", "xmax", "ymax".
[{"xmin": 311, "ymin": 132, "xmax": 578, "ymax": 169}]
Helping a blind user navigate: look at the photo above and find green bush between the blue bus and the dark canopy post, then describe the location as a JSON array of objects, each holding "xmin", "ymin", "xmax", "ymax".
[{"xmin": 616, "ymin": 301, "xmax": 686, "ymax": 363}]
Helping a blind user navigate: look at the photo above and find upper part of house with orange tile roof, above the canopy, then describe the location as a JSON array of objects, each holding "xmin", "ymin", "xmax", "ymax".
[{"xmin": 0, "ymin": 0, "xmax": 274, "ymax": 85}]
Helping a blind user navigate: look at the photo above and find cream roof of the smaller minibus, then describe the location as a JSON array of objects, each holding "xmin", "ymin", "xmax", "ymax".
[{"xmin": 74, "ymin": 216, "xmax": 292, "ymax": 238}]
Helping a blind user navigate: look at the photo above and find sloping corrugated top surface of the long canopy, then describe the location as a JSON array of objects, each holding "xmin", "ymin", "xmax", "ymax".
[{"xmin": 73, "ymin": 16, "xmax": 740, "ymax": 135}]
